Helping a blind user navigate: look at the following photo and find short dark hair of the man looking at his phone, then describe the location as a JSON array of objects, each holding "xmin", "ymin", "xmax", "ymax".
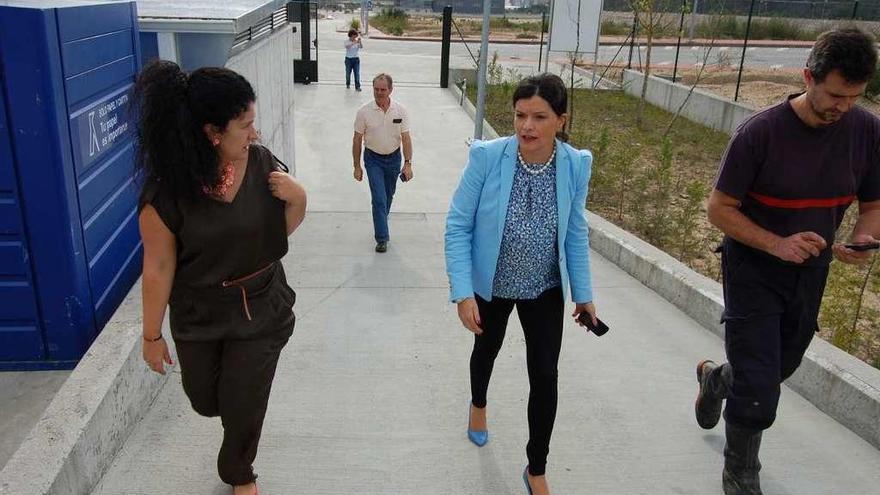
[{"xmin": 807, "ymin": 27, "xmax": 877, "ymax": 84}]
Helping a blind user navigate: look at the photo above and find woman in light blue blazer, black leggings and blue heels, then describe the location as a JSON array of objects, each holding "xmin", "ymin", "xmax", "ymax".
[{"xmin": 446, "ymin": 74, "xmax": 596, "ymax": 495}]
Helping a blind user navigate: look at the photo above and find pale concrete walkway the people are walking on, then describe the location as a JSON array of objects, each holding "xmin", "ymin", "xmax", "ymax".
[{"xmin": 87, "ymin": 54, "xmax": 880, "ymax": 495}]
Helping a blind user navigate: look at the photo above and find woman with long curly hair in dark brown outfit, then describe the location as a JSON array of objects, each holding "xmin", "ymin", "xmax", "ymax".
[{"xmin": 135, "ymin": 61, "xmax": 306, "ymax": 495}]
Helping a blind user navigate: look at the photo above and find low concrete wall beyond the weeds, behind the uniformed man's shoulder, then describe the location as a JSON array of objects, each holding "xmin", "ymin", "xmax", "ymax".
[{"xmin": 623, "ymin": 70, "xmax": 755, "ymax": 134}]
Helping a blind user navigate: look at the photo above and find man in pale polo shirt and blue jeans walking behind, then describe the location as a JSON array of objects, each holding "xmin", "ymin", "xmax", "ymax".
[{"xmin": 351, "ymin": 74, "xmax": 413, "ymax": 253}]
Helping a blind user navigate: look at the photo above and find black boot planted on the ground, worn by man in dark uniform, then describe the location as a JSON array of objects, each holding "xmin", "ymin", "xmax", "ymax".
[{"xmin": 721, "ymin": 423, "xmax": 763, "ymax": 495}]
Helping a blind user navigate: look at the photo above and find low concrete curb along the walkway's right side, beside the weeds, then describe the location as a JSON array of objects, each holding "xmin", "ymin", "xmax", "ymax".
[{"xmin": 449, "ymin": 83, "xmax": 880, "ymax": 449}]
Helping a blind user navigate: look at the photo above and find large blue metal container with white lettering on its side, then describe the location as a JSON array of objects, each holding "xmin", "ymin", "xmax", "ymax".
[{"xmin": 0, "ymin": 2, "xmax": 142, "ymax": 369}]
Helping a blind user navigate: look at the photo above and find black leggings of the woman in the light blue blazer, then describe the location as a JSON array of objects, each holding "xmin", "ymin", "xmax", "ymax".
[{"xmin": 471, "ymin": 287, "xmax": 565, "ymax": 476}]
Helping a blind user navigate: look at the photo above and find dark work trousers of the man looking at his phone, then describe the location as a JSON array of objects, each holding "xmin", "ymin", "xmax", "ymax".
[{"xmin": 710, "ymin": 239, "xmax": 828, "ymax": 430}]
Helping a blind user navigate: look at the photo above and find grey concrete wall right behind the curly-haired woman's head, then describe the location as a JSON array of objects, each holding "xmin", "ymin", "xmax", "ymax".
[{"xmin": 226, "ymin": 26, "xmax": 297, "ymax": 175}]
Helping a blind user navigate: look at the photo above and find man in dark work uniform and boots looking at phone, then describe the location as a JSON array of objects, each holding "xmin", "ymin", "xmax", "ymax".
[{"xmin": 695, "ymin": 28, "xmax": 880, "ymax": 495}]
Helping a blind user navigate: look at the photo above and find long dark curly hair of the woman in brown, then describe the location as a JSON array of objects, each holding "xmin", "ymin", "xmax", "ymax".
[{"xmin": 135, "ymin": 60, "xmax": 257, "ymax": 204}]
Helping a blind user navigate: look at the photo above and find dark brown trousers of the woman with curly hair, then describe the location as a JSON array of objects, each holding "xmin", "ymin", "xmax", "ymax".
[{"xmin": 175, "ymin": 331, "xmax": 290, "ymax": 485}]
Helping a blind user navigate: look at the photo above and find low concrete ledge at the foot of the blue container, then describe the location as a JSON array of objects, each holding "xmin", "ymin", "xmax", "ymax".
[{"xmin": 0, "ymin": 282, "xmax": 168, "ymax": 495}]
